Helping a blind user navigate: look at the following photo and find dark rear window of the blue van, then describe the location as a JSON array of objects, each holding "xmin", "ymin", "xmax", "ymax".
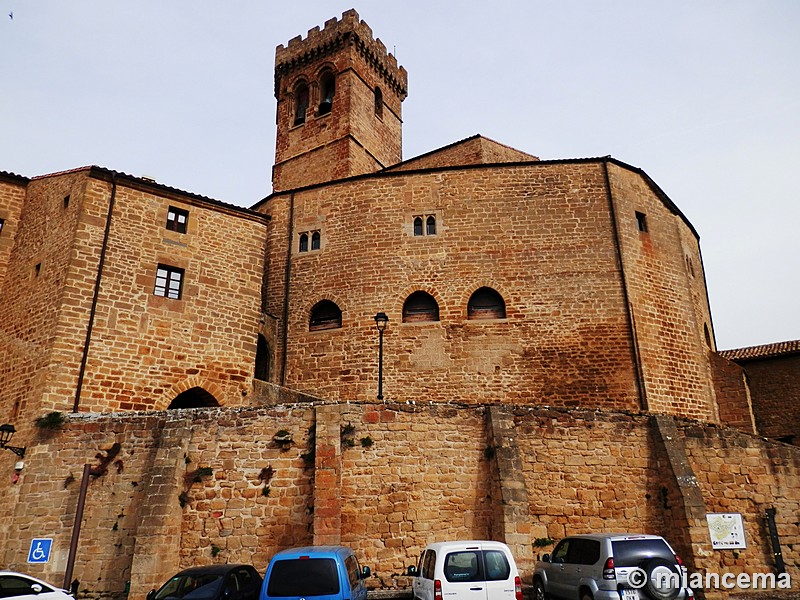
[{"xmin": 267, "ymin": 558, "xmax": 339, "ymax": 596}]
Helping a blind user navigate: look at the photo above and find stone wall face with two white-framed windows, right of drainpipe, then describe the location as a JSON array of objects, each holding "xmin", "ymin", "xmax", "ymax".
[{"xmin": 70, "ymin": 177, "xmax": 266, "ymax": 412}]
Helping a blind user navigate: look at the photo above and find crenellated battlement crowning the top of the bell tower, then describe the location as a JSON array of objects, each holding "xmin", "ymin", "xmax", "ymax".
[{"xmin": 275, "ymin": 9, "xmax": 408, "ymax": 100}]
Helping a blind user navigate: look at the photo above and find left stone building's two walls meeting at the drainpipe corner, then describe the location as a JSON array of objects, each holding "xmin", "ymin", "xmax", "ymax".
[{"xmin": 0, "ymin": 168, "xmax": 266, "ymax": 437}]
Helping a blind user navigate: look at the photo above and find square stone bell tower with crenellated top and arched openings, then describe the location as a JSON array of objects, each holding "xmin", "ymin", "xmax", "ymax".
[{"xmin": 272, "ymin": 10, "xmax": 408, "ymax": 192}]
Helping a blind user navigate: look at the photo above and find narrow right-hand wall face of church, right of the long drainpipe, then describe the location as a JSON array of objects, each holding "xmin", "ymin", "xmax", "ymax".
[{"xmin": 607, "ymin": 163, "xmax": 719, "ymax": 422}]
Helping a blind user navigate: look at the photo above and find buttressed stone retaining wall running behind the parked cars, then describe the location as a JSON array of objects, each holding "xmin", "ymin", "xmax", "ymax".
[{"xmin": 0, "ymin": 403, "xmax": 800, "ymax": 599}]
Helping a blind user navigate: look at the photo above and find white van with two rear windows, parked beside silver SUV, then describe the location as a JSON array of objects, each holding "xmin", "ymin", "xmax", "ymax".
[{"xmin": 408, "ymin": 540, "xmax": 522, "ymax": 600}]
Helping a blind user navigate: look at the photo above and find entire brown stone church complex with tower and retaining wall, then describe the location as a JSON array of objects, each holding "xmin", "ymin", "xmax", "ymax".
[{"xmin": 0, "ymin": 10, "xmax": 800, "ymax": 599}]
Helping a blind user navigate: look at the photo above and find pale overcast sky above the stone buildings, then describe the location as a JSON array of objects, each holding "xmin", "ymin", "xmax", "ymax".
[{"xmin": 0, "ymin": 0, "xmax": 800, "ymax": 349}]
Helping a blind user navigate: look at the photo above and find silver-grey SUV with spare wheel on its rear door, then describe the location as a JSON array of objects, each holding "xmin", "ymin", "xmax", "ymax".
[{"xmin": 533, "ymin": 533, "xmax": 694, "ymax": 600}]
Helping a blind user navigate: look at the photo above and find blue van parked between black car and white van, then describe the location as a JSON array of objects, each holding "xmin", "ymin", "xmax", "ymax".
[{"xmin": 259, "ymin": 546, "xmax": 371, "ymax": 600}]
